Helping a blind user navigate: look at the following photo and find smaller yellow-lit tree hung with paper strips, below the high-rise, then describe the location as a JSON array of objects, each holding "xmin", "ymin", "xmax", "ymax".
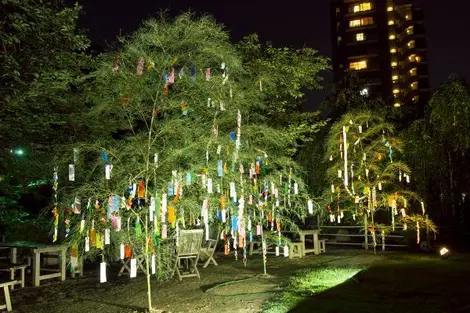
[{"xmin": 325, "ymin": 111, "xmax": 436, "ymax": 252}]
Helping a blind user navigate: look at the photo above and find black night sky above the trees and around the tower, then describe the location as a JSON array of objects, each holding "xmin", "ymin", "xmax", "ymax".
[{"xmin": 72, "ymin": 0, "xmax": 470, "ymax": 101}]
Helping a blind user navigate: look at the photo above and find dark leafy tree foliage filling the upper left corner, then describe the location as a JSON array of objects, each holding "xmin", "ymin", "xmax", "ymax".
[{"xmin": 0, "ymin": 0, "xmax": 92, "ymax": 183}]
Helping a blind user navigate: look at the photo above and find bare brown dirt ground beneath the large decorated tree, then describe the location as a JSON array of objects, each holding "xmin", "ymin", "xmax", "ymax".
[{"xmin": 12, "ymin": 251, "xmax": 382, "ymax": 313}]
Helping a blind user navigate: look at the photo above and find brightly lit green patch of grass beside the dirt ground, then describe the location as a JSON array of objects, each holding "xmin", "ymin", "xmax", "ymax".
[{"xmin": 263, "ymin": 267, "xmax": 363, "ymax": 313}]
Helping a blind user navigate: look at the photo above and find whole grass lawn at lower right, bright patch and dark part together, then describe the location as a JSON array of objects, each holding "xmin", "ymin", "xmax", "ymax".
[{"xmin": 263, "ymin": 255, "xmax": 470, "ymax": 313}]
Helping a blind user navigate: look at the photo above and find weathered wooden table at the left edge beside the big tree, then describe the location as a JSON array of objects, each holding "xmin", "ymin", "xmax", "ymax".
[{"xmin": 0, "ymin": 241, "xmax": 67, "ymax": 287}]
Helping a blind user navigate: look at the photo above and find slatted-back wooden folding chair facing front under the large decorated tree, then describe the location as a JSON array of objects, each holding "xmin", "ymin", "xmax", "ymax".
[{"xmin": 173, "ymin": 229, "xmax": 204, "ymax": 280}]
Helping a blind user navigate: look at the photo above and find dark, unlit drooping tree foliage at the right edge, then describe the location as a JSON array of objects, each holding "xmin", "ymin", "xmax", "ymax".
[{"xmin": 401, "ymin": 81, "xmax": 470, "ymax": 229}]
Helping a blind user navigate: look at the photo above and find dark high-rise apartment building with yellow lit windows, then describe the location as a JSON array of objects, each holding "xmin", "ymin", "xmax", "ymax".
[{"xmin": 331, "ymin": 0, "xmax": 430, "ymax": 107}]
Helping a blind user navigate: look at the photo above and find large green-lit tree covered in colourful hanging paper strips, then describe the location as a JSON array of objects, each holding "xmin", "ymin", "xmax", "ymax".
[{"xmin": 57, "ymin": 14, "xmax": 324, "ymax": 308}]
